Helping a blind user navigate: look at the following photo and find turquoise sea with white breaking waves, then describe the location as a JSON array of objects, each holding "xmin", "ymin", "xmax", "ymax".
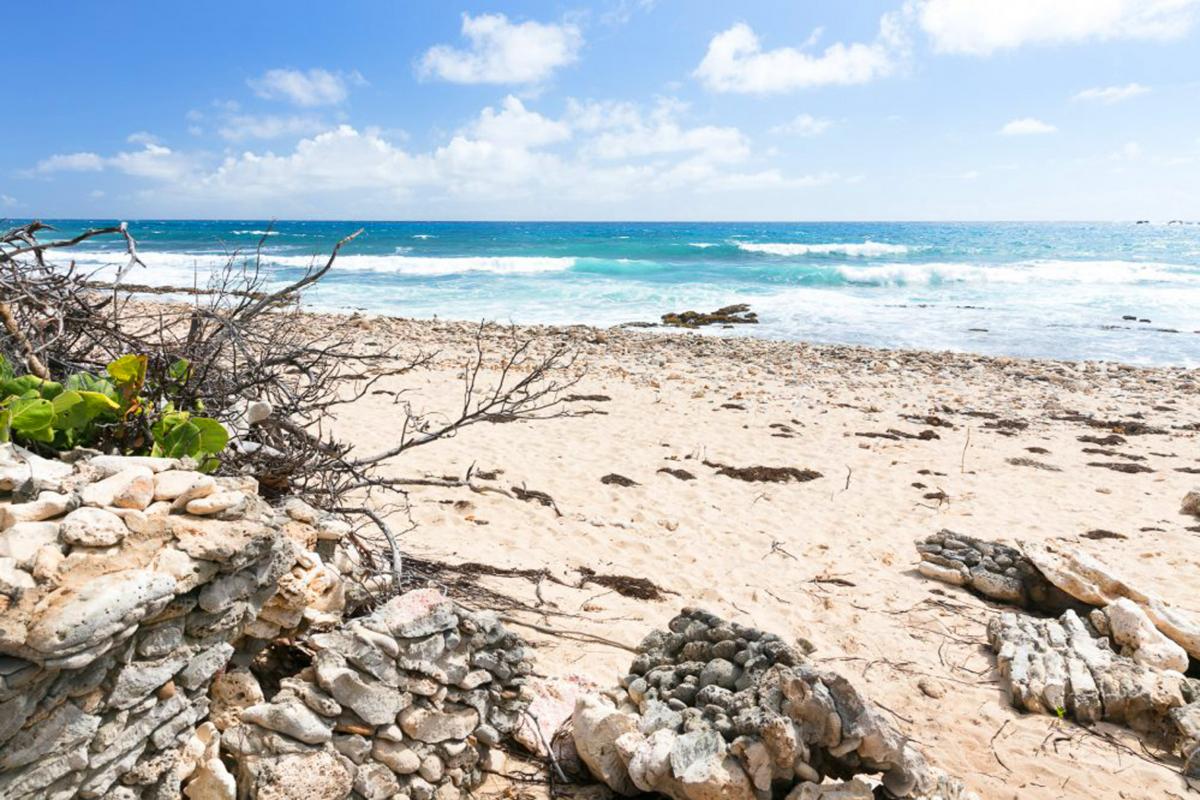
[{"xmin": 32, "ymin": 219, "xmax": 1200, "ymax": 366}]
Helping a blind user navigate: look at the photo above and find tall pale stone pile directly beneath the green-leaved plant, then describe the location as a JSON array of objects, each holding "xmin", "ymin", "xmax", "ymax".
[{"xmin": 0, "ymin": 444, "xmax": 342, "ymax": 800}]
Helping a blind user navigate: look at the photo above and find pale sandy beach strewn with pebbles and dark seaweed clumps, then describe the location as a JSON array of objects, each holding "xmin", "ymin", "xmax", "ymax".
[{"xmin": 304, "ymin": 315, "xmax": 1200, "ymax": 800}]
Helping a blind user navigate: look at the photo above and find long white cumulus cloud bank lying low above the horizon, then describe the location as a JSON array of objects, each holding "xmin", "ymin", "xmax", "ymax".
[{"xmin": 28, "ymin": 96, "xmax": 839, "ymax": 213}]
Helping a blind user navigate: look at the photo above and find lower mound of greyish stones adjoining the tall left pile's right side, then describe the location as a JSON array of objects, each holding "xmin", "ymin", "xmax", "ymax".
[{"xmin": 219, "ymin": 590, "xmax": 529, "ymax": 800}]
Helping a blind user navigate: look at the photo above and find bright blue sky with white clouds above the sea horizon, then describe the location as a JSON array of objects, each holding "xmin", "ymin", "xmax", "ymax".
[{"xmin": 0, "ymin": 0, "xmax": 1200, "ymax": 221}]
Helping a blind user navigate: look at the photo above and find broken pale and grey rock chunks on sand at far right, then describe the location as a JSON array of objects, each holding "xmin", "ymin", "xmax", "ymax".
[{"xmin": 917, "ymin": 531, "xmax": 1200, "ymax": 777}]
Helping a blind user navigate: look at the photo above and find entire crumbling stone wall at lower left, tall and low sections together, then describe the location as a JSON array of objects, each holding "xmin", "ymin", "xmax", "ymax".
[{"xmin": 0, "ymin": 445, "xmax": 528, "ymax": 800}]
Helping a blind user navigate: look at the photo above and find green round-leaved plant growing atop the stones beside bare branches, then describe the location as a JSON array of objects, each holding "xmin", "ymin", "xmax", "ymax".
[{"xmin": 0, "ymin": 355, "xmax": 229, "ymax": 471}]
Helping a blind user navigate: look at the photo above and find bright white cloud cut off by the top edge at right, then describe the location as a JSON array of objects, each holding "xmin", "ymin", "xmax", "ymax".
[{"xmin": 916, "ymin": 0, "xmax": 1200, "ymax": 55}]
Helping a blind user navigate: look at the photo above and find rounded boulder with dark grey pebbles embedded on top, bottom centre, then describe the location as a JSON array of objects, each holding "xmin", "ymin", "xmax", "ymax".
[{"xmin": 572, "ymin": 609, "xmax": 968, "ymax": 800}]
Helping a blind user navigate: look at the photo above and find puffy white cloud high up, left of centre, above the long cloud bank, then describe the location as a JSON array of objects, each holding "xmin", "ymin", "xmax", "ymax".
[{"xmin": 420, "ymin": 14, "xmax": 583, "ymax": 84}]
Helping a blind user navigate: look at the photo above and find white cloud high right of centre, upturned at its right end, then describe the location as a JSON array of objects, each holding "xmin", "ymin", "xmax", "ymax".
[{"xmin": 692, "ymin": 14, "xmax": 907, "ymax": 95}]
